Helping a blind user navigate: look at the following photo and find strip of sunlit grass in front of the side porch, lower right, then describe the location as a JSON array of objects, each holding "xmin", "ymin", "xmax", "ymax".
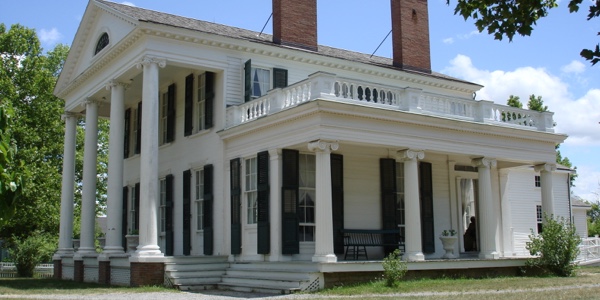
[{"xmin": 315, "ymin": 267, "xmax": 600, "ymax": 300}]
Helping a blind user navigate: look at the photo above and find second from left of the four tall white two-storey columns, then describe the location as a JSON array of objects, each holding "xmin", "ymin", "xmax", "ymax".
[{"xmin": 77, "ymin": 99, "xmax": 98, "ymax": 254}]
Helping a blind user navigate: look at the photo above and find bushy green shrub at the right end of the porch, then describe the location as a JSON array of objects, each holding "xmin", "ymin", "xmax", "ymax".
[{"xmin": 527, "ymin": 215, "xmax": 581, "ymax": 277}]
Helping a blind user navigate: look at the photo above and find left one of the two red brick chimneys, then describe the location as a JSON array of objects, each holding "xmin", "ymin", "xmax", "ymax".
[{"xmin": 273, "ymin": 0, "xmax": 317, "ymax": 51}]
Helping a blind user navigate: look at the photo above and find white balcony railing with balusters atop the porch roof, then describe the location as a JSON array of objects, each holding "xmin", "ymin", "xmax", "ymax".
[{"xmin": 227, "ymin": 72, "xmax": 554, "ymax": 132}]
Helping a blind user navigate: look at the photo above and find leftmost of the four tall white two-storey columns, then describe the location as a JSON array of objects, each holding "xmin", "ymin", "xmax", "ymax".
[{"xmin": 56, "ymin": 112, "xmax": 77, "ymax": 259}]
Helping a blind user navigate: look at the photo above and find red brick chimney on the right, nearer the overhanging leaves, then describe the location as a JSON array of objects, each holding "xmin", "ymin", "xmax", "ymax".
[{"xmin": 391, "ymin": 0, "xmax": 431, "ymax": 73}]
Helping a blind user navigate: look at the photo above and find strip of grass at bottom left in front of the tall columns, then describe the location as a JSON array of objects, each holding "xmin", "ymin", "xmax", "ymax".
[{"xmin": 0, "ymin": 278, "xmax": 177, "ymax": 295}]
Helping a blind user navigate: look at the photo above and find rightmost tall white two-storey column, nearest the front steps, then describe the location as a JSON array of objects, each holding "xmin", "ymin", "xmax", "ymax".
[{"xmin": 134, "ymin": 57, "xmax": 166, "ymax": 257}]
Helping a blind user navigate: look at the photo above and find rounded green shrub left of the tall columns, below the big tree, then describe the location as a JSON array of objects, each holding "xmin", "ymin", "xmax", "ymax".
[{"xmin": 8, "ymin": 232, "xmax": 56, "ymax": 277}]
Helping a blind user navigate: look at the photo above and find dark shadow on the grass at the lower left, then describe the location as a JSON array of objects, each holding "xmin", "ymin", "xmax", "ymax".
[{"xmin": 0, "ymin": 278, "xmax": 122, "ymax": 294}]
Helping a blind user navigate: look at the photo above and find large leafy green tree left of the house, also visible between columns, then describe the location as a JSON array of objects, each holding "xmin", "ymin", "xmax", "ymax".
[{"xmin": 0, "ymin": 24, "xmax": 108, "ymax": 244}]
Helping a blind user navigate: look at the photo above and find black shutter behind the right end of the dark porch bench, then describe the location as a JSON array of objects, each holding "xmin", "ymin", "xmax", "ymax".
[{"xmin": 379, "ymin": 158, "xmax": 400, "ymax": 256}]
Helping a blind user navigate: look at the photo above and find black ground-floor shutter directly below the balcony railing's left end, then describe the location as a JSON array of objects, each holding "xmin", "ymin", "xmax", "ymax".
[{"xmin": 230, "ymin": 158, "xmax": 242, "ymax": 254}]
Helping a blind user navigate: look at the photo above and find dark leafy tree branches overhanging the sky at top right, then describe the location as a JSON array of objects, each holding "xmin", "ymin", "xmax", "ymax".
[{"xmin": 446, "ymin": 0, "xmax": 600, "ymax": 65}]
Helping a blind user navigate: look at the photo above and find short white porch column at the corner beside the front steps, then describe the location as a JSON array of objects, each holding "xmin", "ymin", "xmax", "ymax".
[{"xmin": 308, "ymin": 140, "xmax": 339, "ymax": 262}]
